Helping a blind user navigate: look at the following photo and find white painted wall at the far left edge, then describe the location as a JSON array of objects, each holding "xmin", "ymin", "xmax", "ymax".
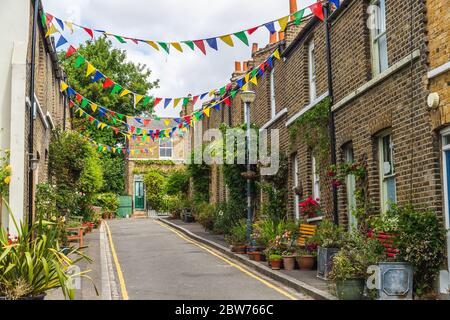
[{"xmin": 0, "ymin": 0, "xmax": 31, "ymax": 234}]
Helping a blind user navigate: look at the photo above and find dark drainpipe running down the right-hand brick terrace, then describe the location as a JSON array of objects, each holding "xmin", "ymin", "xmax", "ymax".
[{"xmin": 323, "ymin": 0, "xmax": 339, "ymax": 224}]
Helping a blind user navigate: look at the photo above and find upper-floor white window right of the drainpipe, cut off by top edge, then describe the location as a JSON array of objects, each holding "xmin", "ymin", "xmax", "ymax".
[{"xmin": 370, "ymin": 0, "xmax": 389, "ymax": 76}]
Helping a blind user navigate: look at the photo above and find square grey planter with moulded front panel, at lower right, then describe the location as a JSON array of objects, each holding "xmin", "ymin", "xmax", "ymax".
[{"xmin": 377, "ymin": 262, "xmax": 413, "ymax": 300}]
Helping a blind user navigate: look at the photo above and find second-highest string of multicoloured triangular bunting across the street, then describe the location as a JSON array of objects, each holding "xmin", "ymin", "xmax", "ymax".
[{"xmin": 56, "ymin": 29, "xmax": 280, "ymax": 109}]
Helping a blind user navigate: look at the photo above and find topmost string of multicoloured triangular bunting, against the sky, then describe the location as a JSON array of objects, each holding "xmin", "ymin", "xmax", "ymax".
[{"xmin": 42, "ymin": 0, "xmax": 330, "ymax": 55}]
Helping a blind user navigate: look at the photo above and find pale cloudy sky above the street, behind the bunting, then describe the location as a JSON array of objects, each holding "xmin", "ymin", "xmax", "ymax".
[{"xmin": 42, "ymin": 0, "xmax": 316, "ymax": 116}]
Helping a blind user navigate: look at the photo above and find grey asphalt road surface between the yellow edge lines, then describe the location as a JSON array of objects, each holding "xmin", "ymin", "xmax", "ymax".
[{"xmin": 108, "ymin": 219, "xmax": 305, "ymax": 300}]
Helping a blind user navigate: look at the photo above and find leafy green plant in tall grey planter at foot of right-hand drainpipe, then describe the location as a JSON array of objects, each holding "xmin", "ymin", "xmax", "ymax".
[{"xmin": 310, "ymin": 219, "xmax": 344, "ymax": 280}]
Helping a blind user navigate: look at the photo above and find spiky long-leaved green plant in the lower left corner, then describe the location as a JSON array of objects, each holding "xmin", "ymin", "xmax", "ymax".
[{"xmin": 0, "ymin": 201, "xmax": 94, "ymax": 300}]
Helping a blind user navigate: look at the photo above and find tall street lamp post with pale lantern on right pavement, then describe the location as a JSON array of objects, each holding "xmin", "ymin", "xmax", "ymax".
[{"xmin": 241, "ymin": 91, "xmax": 256, "ymax": 242}]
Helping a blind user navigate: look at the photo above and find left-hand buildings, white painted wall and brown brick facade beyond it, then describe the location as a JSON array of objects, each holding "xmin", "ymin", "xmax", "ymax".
[{"xmin": 0, "ymin": 1, "xmax": 70, "ymax": 232}]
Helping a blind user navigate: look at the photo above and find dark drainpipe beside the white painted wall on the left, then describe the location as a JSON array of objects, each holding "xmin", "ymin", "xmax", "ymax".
[{"xmin": 28, "ymin": 0, "xmax": 39, "ymax": 228}]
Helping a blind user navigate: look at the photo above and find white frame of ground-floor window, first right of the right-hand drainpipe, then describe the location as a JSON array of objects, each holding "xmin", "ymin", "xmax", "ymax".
[{"xmin": 378, "ymin": 131, "xmax": 397, "ymax": 213}]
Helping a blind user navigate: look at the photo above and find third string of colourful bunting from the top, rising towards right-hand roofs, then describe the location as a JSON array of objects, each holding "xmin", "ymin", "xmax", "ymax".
[{"xmin": 61, "ymin": 48, "xmax": 280, "ymax": 135}]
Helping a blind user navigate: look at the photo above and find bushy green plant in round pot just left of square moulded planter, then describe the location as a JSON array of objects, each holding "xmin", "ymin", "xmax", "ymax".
[{"xmin": 329, "ymin": 233, "xmax": 383, "ymax": 300}]
